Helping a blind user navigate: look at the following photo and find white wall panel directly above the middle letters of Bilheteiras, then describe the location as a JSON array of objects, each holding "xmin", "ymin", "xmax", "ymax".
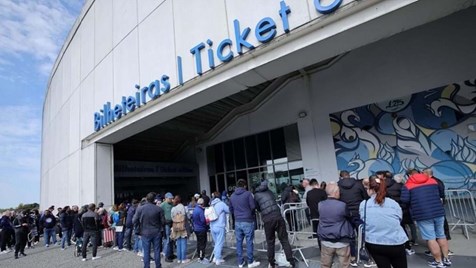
[{"xmin": 111, "ymin": 28, "xmax": 139, "ymax": 100}]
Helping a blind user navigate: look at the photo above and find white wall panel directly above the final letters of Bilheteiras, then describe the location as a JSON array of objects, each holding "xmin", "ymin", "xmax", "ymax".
[{"xmin": 139, "ymin": 1, "xmax": 177, "ymax": 90}]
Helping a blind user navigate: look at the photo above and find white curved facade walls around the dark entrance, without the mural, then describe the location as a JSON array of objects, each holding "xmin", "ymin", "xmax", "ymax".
[{"xmin": 40, "ymin": 0, "xmax": 476, "ymax": 207}]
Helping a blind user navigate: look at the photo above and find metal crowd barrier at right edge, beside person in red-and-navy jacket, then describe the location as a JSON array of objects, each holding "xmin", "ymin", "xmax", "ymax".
[{"xmin": 445, "ymin": 190, "xmax": 476, "ymax": 239}]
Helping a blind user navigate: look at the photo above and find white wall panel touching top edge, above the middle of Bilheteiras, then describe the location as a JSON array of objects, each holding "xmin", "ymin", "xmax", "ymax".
[{"xmin": 112, "ymin": 0, "xmax": 137, "ymax": 47}]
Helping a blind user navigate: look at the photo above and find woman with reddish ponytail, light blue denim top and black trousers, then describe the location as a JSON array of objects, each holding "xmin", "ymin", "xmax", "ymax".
[{"xmin": 359, "ymin": 176, "xmax": 408, "ymax": 268}]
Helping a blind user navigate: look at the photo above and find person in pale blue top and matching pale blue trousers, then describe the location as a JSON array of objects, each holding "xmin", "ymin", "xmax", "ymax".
[{"xmin": 210, "ymin": 192, "xmax": 230, "ymax": 265}]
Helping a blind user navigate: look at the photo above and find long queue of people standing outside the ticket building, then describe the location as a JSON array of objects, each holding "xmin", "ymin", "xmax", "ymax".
[{"xmin": 0, "ymin": 169, "xmax": 452, "ymax": 268}]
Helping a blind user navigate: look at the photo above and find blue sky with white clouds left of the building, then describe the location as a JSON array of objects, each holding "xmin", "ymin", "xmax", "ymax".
[{"xmin": 0, "ymin": 0, "xmax": 85, "ymax": 208}]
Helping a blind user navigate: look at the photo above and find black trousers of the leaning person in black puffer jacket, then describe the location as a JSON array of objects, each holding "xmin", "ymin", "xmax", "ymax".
[{"xmin": 264, "ymin": 217, "xmax": 294, "ymax": 266}]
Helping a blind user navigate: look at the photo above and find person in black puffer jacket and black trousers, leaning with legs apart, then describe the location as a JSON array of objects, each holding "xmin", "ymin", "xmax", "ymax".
[{"xmin": 254, "ymin": 180, "xmax": 296, "ymax": 267}]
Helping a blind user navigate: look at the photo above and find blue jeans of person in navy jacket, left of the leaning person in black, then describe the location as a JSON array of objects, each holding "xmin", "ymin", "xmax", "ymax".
[{"xmin": 235, "ymin": 221, "xmax": 255, "ymax": 265}]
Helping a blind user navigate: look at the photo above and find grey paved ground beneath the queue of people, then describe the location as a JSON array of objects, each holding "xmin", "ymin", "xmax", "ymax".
[{"xmin": 0, "ymin": 228, "xmax": 476, "ymax": 268}]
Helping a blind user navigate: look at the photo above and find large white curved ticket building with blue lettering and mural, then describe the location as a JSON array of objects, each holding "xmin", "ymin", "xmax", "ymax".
[{"xmin": 40, "ymin": 0, "xmax": 476, "ymax": 207}]
